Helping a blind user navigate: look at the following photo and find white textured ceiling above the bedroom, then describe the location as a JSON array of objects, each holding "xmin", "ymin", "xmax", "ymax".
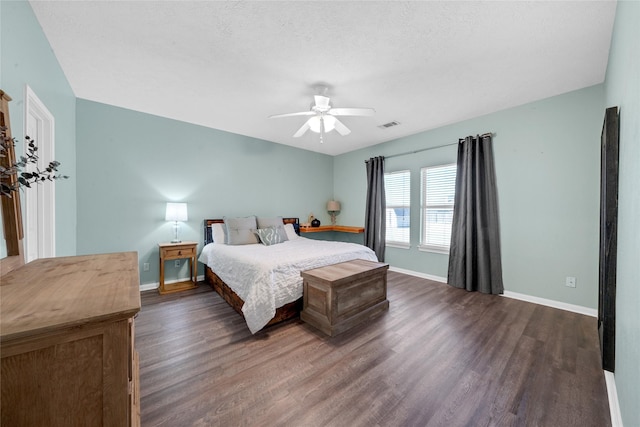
[{"xmin": 30, "ymin": 0, "xmax": 616, "ymax": 155}]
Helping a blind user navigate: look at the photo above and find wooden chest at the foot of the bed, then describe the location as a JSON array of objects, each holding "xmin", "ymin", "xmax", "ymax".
[{"xmin": 300, "ymin": 259, "xmax": 389, "ymax": 336}]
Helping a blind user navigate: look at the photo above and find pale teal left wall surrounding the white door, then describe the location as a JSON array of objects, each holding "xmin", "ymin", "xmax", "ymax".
[{"xmin": 0, "ymin": 1, "xmax": 77, "ymax": 256}]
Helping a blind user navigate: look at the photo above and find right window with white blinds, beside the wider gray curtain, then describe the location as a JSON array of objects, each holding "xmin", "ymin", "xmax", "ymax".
[{"xmin": 420, "ymin": 163, "xmax": 456, "ymax": 253}]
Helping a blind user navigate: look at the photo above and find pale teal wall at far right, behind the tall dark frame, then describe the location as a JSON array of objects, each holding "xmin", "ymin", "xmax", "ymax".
[{"xmin": 605, "ymin": 1, "xmax": 640, "ymax": 426}]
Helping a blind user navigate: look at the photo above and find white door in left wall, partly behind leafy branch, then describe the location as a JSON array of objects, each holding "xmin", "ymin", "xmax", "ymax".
[{"xmin": 22, "ymin": 86, "xmax": 55, "ymax": 262}]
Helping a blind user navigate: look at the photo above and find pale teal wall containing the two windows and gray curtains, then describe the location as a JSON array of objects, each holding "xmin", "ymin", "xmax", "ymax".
[{"xmin": 334, "ymin": 85, "xmax": 604, "ymax": 308}]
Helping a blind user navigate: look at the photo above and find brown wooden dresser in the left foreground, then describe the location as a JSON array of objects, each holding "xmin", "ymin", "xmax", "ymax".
[{"xmin": 0, "ymin": 252, "xmax": 140, "ymax": 426}]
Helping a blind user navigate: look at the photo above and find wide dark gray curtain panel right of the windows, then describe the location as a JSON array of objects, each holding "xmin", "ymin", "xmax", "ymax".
[{"xmin": 448, "ymin": 135, "xmax": 504, "ymax": 294}]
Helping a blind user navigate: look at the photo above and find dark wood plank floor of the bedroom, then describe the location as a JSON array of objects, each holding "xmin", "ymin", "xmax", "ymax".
[{"xmin": 136, "ymin": 272, "xmax": 610, "ymax": 427}]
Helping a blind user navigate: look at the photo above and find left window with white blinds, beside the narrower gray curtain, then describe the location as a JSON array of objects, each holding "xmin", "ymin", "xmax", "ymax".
[{"xmin": 384, "ymin": 171, "xmax": 411, "ymax": 248}]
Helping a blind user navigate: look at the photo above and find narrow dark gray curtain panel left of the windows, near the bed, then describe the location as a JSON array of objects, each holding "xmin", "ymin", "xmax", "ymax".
[{"xmin": 364, "ymin": 156, "xmax": 387, "ymax": 262}]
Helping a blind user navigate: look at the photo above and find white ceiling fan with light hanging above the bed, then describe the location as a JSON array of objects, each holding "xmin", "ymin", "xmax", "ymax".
[{"xmin": 269, "ymin": 86, "xmax": 376, "ymax": 143}]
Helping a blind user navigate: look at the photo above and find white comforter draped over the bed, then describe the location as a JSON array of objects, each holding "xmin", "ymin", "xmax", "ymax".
[{"xmin": 199, "ymin": 237, "xmax": 378, "ymax": 334}]
